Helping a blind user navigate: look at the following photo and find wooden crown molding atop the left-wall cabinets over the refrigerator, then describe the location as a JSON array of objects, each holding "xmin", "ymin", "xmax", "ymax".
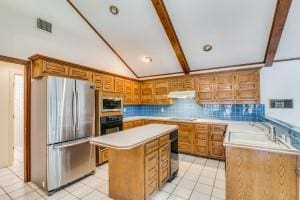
[{"xmin": 28, "ymin": 54, "xmax": 137, "ymax": 81}]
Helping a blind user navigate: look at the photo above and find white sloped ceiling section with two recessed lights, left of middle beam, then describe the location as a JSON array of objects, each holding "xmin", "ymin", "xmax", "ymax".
[{"xmin": 72, "ymin": 0, "xmax": 182, "ymax": 77}]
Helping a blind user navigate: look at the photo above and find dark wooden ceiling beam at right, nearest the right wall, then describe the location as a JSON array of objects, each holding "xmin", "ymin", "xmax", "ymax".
[{"xmin": 265, "ymin": 0, "xmax": 292, "ymax": 67}]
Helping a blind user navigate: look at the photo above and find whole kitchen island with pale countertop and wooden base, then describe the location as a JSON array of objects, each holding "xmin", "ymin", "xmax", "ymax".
[{"xmin": 90, "ymin": 124, "xmax": 178, "ymax": 200}]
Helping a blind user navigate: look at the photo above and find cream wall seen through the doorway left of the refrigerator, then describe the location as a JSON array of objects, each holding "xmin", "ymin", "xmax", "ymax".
[{"xmin": 0, "ymin": 61, "xmax": 24, "ymax": 168}]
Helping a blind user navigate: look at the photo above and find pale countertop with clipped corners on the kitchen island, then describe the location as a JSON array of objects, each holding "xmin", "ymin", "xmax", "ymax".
[{"xmin": 90, "ymin": 124, "xmax": 178, "ymax": 149}]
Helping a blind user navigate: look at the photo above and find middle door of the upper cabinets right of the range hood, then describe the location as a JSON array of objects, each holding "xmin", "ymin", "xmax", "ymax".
[{"xmin": 214, "ymin": 73, "xmax": 235, "ymax": 103}]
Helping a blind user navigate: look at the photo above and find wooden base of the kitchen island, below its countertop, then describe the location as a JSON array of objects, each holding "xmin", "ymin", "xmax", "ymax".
[{"xmin": 109, "ymin": 134, "xmax": 170, "ymax": 200}]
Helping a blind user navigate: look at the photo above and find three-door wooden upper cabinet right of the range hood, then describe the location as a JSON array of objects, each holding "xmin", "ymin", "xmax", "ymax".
[{"xmin": 196, "ymin": 69, "xmax": 260, "ymax": 104}]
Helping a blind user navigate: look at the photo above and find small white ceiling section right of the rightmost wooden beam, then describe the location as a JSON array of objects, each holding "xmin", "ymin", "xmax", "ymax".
[{"xmin": 275, "ymin": 0, "xmax": 300, "ymax": 60}]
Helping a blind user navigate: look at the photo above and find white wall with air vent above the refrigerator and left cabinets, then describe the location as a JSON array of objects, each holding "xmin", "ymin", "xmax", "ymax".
[{"xmin": 0, "ymin": 0, "xmax": 133, "ymax": 77}]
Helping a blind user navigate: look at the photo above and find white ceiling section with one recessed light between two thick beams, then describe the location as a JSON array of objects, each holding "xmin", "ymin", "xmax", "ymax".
[{"xmin": 164, "ymin": 0, "xmax": 276, "ymax": 71}]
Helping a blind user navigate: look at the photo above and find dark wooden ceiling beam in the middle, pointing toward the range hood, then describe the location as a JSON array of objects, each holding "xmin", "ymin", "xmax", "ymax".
[{"xmin": 152, "ymin": 0, "xmax": 190, "ymax": 74}]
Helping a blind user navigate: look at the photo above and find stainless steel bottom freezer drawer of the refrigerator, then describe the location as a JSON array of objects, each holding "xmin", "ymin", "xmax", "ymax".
[{"xmin": 47, "ymin": 139, "xmax": 96, "ymax": 191}]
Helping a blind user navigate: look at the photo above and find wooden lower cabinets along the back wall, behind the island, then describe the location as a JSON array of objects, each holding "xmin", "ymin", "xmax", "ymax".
[{"xmin": 123, "ymin": 119, "xmax": 227, "ymax": 160}]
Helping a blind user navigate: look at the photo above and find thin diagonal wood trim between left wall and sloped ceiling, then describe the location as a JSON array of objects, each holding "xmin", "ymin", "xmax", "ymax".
[{"xmin": 67, "ymin": 0, "xmax": 139, "ymax": 78}]
